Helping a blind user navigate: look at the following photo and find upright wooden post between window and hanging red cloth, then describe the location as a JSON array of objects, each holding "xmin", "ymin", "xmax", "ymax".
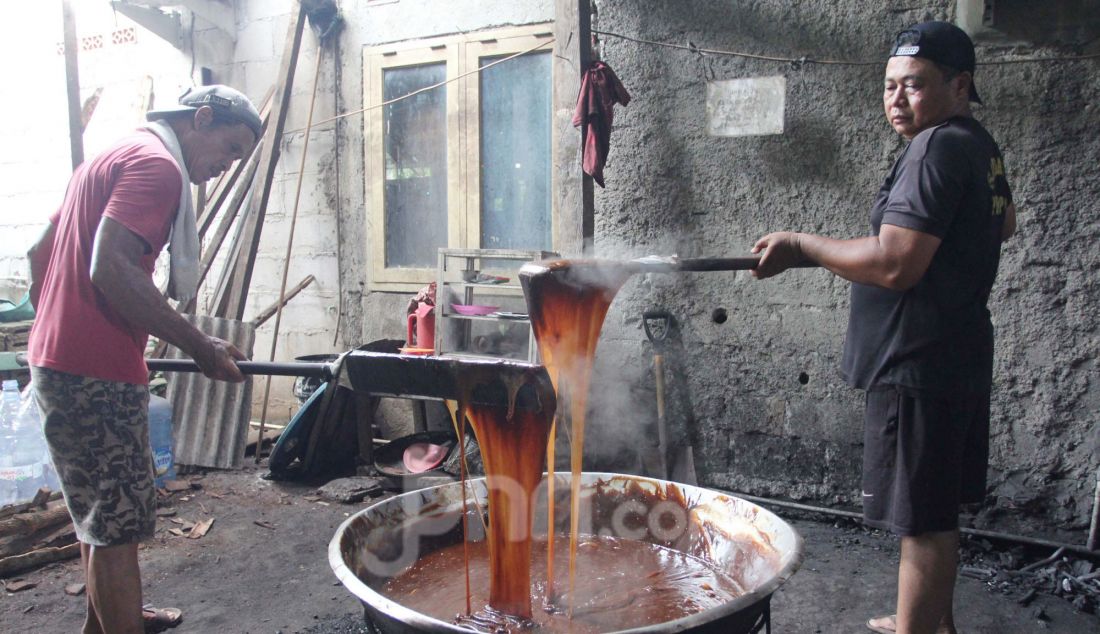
[{"xmin": 551, "ymin": 0, "xmax": 595, "ymax": 255}]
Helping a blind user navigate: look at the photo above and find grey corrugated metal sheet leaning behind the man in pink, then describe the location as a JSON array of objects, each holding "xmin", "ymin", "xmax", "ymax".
[{"xmin": 167, "ymin": 315, "xmax": 256, "ymax": 469}]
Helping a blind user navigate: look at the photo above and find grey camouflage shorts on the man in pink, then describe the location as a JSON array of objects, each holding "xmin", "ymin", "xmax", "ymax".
[{"xmin": 31, "ymin": 368, "xmax": 156, "ymax": 546}]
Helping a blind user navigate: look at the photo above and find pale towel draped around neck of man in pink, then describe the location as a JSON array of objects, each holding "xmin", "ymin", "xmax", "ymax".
[{"xmin": 145, "ymin": 120, "xmax": 199, "ymax": 304}]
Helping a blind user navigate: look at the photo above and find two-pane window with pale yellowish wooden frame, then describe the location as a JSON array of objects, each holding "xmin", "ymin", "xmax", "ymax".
[{"xmin": 363, "ymin": 24, "xmax": 554, "ymax": 291}]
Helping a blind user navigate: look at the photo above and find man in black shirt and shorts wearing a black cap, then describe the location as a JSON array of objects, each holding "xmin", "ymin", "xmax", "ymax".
[{"xmin": 752, "ymin": 22, "xmax": 1015, "ymax": 634}]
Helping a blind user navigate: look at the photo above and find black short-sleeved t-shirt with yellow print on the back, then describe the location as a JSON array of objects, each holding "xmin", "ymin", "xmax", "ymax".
[{"xmin": 842, "ymin": 117, "xmax": 1012, "ymax": 394}]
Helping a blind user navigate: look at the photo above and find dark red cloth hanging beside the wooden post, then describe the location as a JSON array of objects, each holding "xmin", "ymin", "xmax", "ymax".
[{"xmin": 573, "ymin": 62, "xmax": 630, "ymax": 187}]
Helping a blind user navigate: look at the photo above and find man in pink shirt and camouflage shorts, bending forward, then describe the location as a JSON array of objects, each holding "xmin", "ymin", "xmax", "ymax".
[{"xmin": 28, "ymin": 86, "xmax": 261, "ymax": 634}]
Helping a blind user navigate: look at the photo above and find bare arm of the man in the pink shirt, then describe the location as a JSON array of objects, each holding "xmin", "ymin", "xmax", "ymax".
[{"xmin": 90, "ymin": 217, "xmax": 245, "ymax": 381}]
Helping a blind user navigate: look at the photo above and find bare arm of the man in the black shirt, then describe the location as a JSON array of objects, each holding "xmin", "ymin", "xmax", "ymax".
[{"xmin": 752, "ymin": 225, "xmax": 941, "ymax": 291}]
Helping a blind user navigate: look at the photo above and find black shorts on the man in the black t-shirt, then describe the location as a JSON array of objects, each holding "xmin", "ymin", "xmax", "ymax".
[{"xmin": 862, "ymin": 385, "xmax": 989, "ymax": 536}]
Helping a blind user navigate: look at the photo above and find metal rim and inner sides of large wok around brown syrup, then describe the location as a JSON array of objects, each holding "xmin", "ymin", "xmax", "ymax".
[{"xmin": 329, "ymin": 472, "xmax": 802, "ymax": 634}]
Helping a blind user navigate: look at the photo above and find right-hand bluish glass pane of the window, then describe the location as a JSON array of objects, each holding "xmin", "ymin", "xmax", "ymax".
[{"xmin": 480, "ymin": 53, "xmax": 551, "ymax": 250}]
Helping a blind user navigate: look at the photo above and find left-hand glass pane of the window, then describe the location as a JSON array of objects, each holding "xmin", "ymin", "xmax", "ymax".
[{"xmin": 383, "ymin": 63, "xmax": 447, "ymax": 267}]
